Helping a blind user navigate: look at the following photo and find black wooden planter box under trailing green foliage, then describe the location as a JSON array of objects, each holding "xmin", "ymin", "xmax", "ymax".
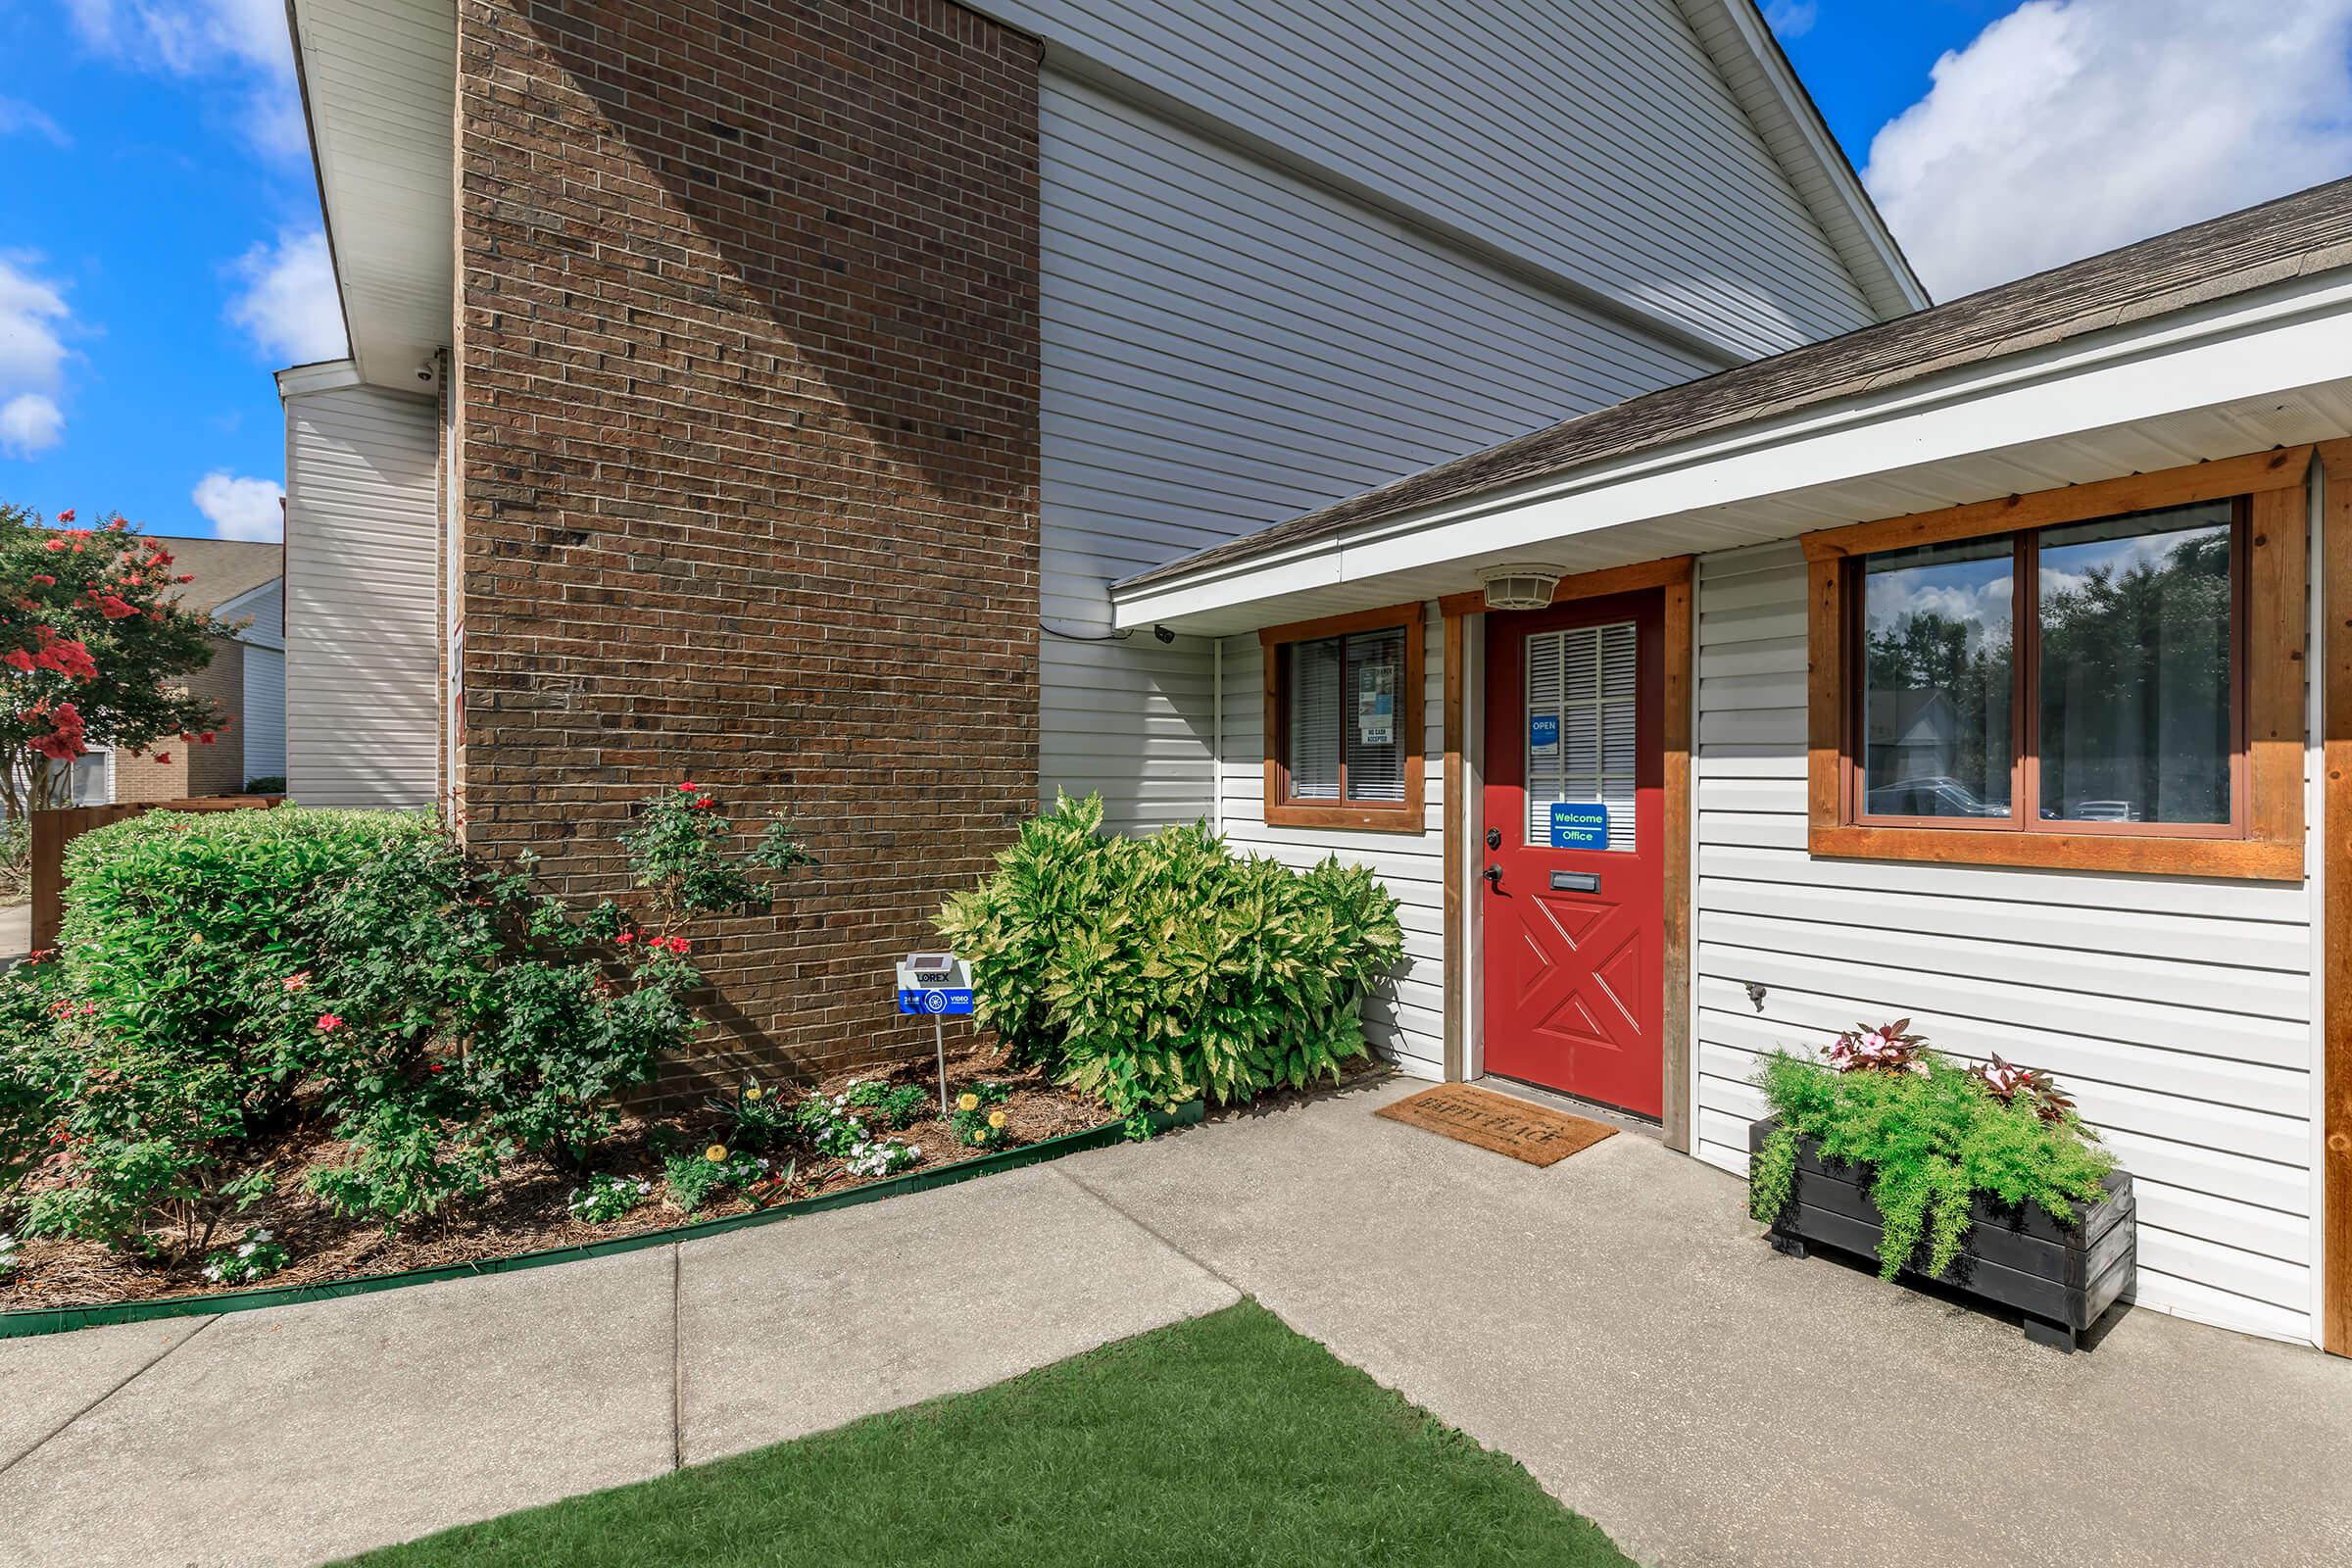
[{"xmin": 1747, "ymin": 1116, "xmax": 2138, "ymax": 1349}]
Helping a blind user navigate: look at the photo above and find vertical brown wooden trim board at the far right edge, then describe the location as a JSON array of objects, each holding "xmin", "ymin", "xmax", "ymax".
[{"xmin": 2317, "ymin": 440, "xmax": 2352, "ymax": 1356}]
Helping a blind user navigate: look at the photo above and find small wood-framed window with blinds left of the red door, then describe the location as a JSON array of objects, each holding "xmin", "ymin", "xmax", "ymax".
[{"xmin": 1260, "ymin": 604, "xmax": 1421, "ymax": 832}]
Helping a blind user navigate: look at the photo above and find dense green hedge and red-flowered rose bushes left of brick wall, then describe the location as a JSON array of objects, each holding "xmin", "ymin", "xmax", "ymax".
[{"xmin": 0, "ymin": 792, "xmax": 807, "ymax": 1257}]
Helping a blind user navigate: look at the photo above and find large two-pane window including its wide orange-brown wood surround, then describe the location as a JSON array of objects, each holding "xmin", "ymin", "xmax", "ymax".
[{"xmin": 1804, "ymin": 449, "xmax": 2310, "ymax": 879}]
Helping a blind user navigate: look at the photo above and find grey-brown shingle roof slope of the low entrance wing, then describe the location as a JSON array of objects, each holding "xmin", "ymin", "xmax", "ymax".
[{"xmin": 1119, "ymin": 178, "xmax": 2352, "ymax": 588}]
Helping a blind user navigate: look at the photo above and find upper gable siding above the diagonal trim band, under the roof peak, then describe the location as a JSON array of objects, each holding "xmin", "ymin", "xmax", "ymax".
[{"xmin": 986, "ymin": 0, "xmax": 1877, "ymax": 358}]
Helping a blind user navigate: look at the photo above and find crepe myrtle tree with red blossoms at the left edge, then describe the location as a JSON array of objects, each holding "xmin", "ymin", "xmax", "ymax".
[{"xmin": 0, "ymin": 503, "xmax": 233, "ymax": 820}]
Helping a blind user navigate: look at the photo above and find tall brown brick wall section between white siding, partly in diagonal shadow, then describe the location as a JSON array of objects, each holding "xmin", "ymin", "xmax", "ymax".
[{"xmin": 457, "ymin": 0, "xmax": 1037, "ymax": 1091}]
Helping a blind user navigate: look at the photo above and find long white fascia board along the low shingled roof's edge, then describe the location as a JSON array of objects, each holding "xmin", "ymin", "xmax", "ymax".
[{"xmin": 1112, "ymin": 272, "xmax": 2352, "ymax": 630}]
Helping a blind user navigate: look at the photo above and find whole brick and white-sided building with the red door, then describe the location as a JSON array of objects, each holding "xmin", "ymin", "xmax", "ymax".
[{"xmin": 282, "ymin": 0, "xmax": 2352, "ymax": 1345}]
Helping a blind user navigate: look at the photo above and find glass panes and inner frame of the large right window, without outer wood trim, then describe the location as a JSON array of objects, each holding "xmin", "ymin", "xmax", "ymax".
[{"xmin": 1851, "ymin": 501, "xmax": 2246, "ymax": 837}]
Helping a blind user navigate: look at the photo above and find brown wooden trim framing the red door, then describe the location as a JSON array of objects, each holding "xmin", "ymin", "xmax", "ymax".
[{"xmin": 1437, "ymin": 555, "xmax": 1698, "ymax": 1154}]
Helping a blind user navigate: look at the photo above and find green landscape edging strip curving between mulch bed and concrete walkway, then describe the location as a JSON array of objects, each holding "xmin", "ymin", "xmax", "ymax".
[{"xmin": 0, "ymin": 1101, "xmax": 1209, "ymax": 1340}]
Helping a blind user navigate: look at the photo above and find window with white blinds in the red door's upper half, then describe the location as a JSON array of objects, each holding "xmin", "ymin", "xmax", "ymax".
[{"xmin": 1524, "ymin": 620, "xmax": 1640, "ymax": 854}]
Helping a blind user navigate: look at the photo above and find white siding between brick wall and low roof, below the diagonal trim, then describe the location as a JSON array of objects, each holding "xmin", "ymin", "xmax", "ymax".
[{"xmin": 1040, "ymin": 73, "xmax": 1705, "ymax": 832}]
